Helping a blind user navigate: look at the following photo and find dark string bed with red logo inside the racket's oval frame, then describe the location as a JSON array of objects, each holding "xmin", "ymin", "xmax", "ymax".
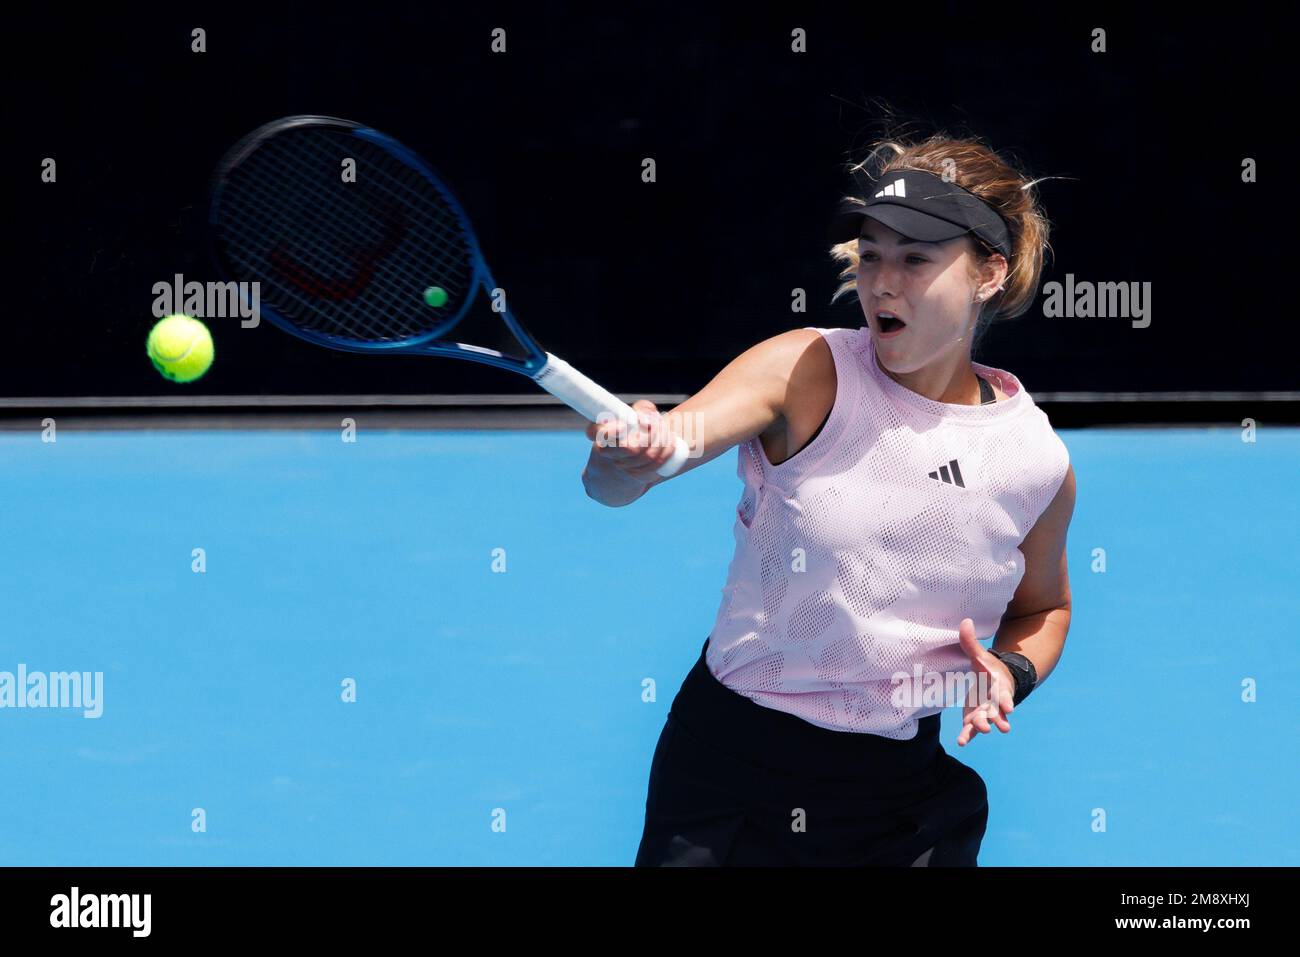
[{"xmin": 213, "ymin": 127, "xmax": 475, "ymax": 342}]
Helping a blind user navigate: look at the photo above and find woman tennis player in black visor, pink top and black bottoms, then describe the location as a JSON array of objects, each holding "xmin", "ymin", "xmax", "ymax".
[{"xmin": 582, "ymin": 135, "xmax": 1075, "ymax": 866}]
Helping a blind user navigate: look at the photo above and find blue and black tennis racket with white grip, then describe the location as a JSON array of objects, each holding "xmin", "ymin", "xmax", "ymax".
[{"xmin": 208, "ymin": 116, "xmax": 689, "ymax": 476}]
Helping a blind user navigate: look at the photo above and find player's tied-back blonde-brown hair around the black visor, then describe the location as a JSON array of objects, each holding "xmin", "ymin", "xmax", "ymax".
[{"xmin": 831, "ymin": 133, "xmax": 1052, "ymax": 351}]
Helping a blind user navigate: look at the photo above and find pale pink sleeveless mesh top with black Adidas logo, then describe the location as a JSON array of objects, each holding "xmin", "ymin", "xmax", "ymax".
[{"xmin": 706, "ymin": 326, "xmax": 1070, "ymax": 740}]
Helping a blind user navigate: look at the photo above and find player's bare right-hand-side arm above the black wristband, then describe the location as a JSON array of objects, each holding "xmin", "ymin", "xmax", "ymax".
[{"xmin": 993, "ymin": 465, "xmax": 1074, "ymax": 684}]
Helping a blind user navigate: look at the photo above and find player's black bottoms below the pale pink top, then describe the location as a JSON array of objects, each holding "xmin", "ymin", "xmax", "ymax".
[{"xmin": 636, "ymin": 641, "xmax": 988, "ymax": 867}]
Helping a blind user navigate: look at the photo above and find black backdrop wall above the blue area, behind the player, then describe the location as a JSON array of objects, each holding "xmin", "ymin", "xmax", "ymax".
[{"xmin": 0, "ymin": 4, "xmax": 1296, "ymax": 397}]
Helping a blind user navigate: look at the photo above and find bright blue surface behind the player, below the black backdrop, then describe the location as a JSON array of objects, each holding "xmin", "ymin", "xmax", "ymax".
[{"xmin": 0, "ymin": 428, "xmax": 1300, "ymax": 866}]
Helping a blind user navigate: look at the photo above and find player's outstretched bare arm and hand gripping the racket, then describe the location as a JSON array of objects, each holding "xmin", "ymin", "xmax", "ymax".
[{"xmin": 582, "ymin": 329, "xmax": 822, "ymax": 507}]
